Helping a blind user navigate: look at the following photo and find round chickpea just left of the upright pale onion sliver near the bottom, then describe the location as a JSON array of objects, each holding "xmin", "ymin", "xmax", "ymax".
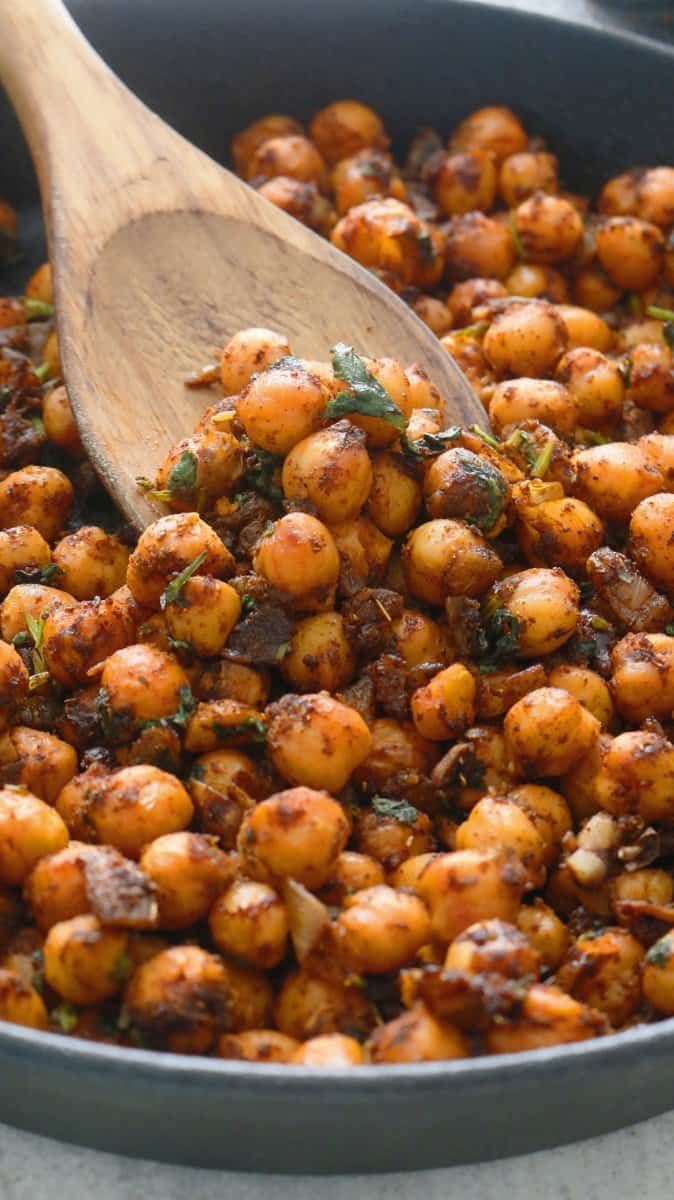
[{"xmin": 209, "ymin": 880, "xmax": 288, "ymax": 971}]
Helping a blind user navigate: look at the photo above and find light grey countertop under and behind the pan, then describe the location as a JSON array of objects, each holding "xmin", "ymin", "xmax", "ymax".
[{"xmin": 5, "ymin": 0, "xmax": 674, "ymax": 1200}]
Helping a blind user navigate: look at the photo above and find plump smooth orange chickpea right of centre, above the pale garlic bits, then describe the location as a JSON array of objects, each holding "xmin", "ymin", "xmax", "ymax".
[{"xmin": 504, "ymin": 688, "xmax": 600, "ymax": 776}]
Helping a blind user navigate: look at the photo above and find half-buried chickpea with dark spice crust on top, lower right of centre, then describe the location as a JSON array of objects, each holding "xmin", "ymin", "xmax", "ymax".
[{"xmin": 445, "ymin": 920, "xmax": 541, "ymax": 979}]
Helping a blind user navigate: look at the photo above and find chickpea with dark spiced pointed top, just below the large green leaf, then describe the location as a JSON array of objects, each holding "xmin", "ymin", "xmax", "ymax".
[{"xmin": 282, "ymin": 421, "xmax": 372, "ymax": 523}]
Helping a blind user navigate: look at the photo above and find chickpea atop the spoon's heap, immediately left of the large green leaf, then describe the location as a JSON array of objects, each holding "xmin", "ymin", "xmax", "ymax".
[{"xmin": 236, "ymin": 360, "xmax": 329, "ymax": 455}]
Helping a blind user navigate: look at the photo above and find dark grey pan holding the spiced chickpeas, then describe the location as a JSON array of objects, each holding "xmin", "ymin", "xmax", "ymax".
[{"xmin": 0, "ymin": 0, "xmax": 674, "ymax": 1174}]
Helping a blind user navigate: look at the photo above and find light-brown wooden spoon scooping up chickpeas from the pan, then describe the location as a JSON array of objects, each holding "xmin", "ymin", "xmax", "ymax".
[{"xmin": 0, "ymin": 0, "xmax": 485, "ymax": 526}]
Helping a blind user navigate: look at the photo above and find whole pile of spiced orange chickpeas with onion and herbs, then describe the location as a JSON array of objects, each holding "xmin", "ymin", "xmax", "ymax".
[{"xmin": 0, "ymin": 101, "xmax": 674, "ymax": 1067}]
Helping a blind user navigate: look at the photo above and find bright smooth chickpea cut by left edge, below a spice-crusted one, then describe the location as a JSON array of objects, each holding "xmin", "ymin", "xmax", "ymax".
[{"xmin": 0, "ymin": 785, "xmax": 68, "ymax": 884}]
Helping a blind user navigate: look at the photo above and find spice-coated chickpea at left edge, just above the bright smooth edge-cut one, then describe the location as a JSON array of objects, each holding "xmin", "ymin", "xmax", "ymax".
[{"xmin": 0, "ymin": 724, "xmax": 77, "ymax": 804}]
